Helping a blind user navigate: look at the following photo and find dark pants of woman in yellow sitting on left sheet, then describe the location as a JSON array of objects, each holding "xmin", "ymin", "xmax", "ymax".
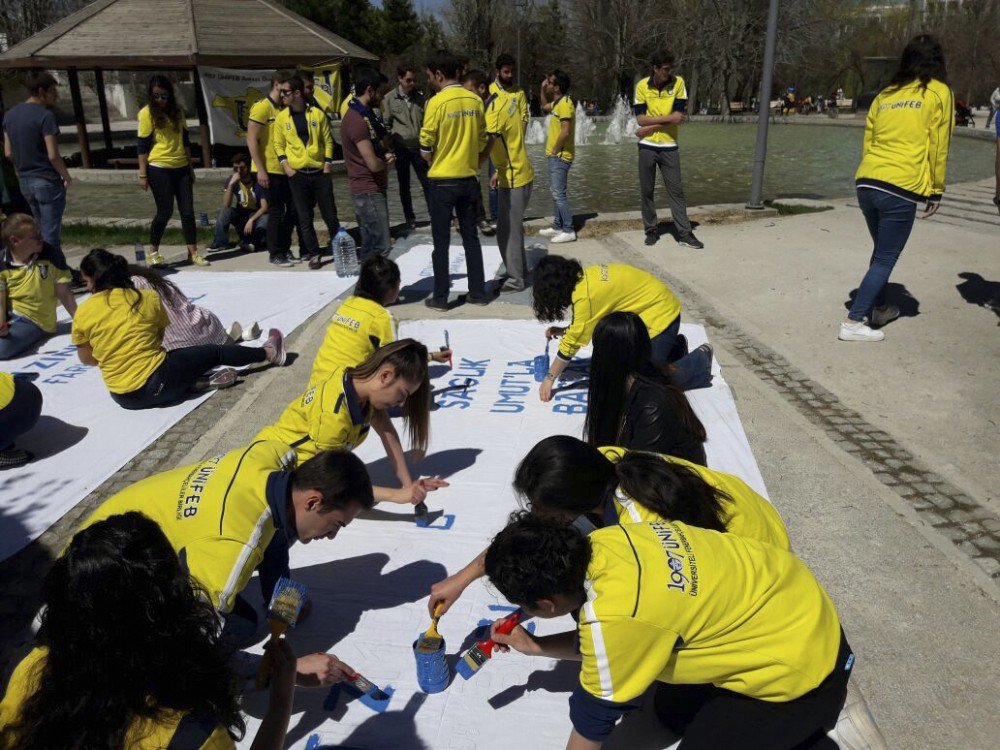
[{"xmin": 111, "ymin": 344, "xmax": 267, "ymax": 409}]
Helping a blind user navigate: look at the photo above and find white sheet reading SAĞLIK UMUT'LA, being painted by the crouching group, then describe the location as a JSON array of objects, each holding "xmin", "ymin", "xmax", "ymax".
[{"xmin": 234, "ymin": 320, "xmax": 763, "ymax": 750}]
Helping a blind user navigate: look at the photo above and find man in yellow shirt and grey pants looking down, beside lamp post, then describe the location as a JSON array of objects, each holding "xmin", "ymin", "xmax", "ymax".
[{"xmin": 632, "ymin": 50, "xmax": 705, "ymax": 250}]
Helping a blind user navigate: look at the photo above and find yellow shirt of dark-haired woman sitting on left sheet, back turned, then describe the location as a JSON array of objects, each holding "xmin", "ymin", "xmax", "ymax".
[{"xmin": 72, "ymin": 289, "xmax": 170, "ymax": 393}]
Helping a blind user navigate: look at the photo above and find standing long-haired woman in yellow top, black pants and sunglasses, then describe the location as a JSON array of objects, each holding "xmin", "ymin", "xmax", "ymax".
[{"xmin": 137, "ymin": 75, "xmax": 209, "ymax": 266}]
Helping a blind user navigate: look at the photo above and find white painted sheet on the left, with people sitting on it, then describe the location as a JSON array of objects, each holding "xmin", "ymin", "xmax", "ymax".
[{"xmin": 0, "ymin": 271, "xmax": 356, "ymax": 560}]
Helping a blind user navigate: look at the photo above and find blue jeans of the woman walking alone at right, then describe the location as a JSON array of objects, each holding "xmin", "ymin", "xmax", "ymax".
[{"xmin": 847, "ymin": 188, "xmax": 917, "ymax": 322}]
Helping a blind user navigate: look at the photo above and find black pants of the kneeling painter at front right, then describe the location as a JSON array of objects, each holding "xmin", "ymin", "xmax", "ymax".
[{"xmin": 654, "ymin": 631, "xmax": 854, "ymax": 750}]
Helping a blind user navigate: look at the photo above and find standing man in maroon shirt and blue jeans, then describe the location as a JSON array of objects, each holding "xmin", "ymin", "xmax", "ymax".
[{"xmin": 340, "ymin": 68, "xmax": 395, "ymax": 261}]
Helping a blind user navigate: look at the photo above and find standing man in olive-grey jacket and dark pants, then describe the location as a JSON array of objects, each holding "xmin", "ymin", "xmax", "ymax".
[{"xmin": 382, "ymin": 64, "xmax": 430, "ymax": 229}]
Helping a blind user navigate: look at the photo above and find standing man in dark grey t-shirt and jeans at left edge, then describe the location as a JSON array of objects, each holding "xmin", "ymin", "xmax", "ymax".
[{"xmin": 3, "ymin": 72, "xmax": 72, "ymax": 268}]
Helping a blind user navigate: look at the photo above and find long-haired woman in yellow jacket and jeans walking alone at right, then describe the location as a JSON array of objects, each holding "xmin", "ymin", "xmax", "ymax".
[{"xmin": 839, "ymin": 34, "xmax": 955, "ymax": 341}]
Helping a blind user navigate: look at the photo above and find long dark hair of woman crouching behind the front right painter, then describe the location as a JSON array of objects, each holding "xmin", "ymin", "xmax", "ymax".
[{"xmin": 514, "ymin": 435, "xmax": 732, "ymax": 531}]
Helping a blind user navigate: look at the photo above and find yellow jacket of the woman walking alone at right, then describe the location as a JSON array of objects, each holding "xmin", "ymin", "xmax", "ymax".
[{"xmin": 854, "ymin": 79, "xmax": 955, "ymax": 203}]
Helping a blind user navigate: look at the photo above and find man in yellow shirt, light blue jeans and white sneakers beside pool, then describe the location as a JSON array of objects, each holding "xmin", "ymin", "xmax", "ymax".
[{"xmin": 538, "ymin": 70, "xmax": 576, "ymax": 243}]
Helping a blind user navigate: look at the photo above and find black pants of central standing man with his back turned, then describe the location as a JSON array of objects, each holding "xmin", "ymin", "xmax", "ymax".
[{"xmin": 430, "ymin": 177, "xmax": 486, "ymax": 302}]
